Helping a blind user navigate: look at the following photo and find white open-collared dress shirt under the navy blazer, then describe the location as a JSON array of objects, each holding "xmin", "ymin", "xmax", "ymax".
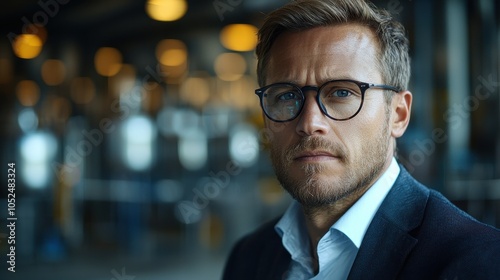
[{"xmin": 275, "ymin": 158, "xmax": 400, "ymax": 280}]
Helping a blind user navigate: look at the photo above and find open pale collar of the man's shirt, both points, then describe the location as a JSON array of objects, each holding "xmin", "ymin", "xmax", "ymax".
[{"xmin": 275, "ymin": 155, "xmax": 400, "ymax": 249}]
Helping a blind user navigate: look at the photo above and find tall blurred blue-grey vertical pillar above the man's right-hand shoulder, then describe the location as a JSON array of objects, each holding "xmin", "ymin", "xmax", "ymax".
[{"xmin": 445, "ymin": 0, "xmax": 470, "ymax": 174}]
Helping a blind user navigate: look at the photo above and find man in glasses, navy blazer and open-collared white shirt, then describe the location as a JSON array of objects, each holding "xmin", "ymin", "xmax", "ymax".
[{"xmin": 224, "ymin": 0, "xmax": 500, "ymax": 280}]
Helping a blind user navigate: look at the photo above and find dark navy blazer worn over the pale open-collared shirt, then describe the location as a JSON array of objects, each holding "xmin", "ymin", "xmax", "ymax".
[{"xmin": 223, "ymin": 166, "xmax": 500, "ymax": 280}]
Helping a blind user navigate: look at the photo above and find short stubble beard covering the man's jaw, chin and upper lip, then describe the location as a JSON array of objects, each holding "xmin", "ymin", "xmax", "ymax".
[{"xmin": 270, "ymin": 117, "xmax": 390, "ymax": 207}]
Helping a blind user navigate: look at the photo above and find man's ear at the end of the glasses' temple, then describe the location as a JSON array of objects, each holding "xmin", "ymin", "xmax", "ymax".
[{"xmin": 390, "ymin": 91, "xmax": 413, "ymax": 138}]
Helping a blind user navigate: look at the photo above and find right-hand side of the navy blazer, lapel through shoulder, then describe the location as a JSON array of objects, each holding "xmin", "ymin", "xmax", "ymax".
[{"xmin": 364, "ymin": 168, "xmax": 500, "ymax": 279}]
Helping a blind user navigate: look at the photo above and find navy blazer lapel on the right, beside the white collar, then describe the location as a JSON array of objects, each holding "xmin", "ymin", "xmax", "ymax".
[{"xmin": 348, "ymin": 166, "xmax": 429, "ymax": 279}]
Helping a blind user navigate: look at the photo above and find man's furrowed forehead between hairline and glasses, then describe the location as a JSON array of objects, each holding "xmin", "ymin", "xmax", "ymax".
[{"xmin": 267, "ymin": 23, "xmax": 380, "ymax": 82}]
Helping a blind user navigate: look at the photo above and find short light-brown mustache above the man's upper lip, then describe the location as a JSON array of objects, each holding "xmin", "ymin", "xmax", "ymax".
[{"xmin": 285, "ymin": 136, "xmax": 347, "ymax": 161}]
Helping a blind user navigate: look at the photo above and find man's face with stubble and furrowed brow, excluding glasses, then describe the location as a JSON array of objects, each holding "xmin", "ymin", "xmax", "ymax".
[{"xmin": 265, "ymin": 24, "xmax": 393, "ymax": 206}]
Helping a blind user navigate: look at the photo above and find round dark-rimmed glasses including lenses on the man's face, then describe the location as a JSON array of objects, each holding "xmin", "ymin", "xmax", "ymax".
[{"xmin": 255, "ymin": 80, "xmax": 400, "ymax": 122}]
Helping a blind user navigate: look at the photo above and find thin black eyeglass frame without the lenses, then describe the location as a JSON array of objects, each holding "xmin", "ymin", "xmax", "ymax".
[{"xmin": 255, "ymin": 79, "xmax": 401, "ymax": 122}]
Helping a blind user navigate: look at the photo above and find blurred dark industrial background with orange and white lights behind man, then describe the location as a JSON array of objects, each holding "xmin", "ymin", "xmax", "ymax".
[{"xmin": 0, "ymin": 0, "xmax": 500, "ymax": 280}]
